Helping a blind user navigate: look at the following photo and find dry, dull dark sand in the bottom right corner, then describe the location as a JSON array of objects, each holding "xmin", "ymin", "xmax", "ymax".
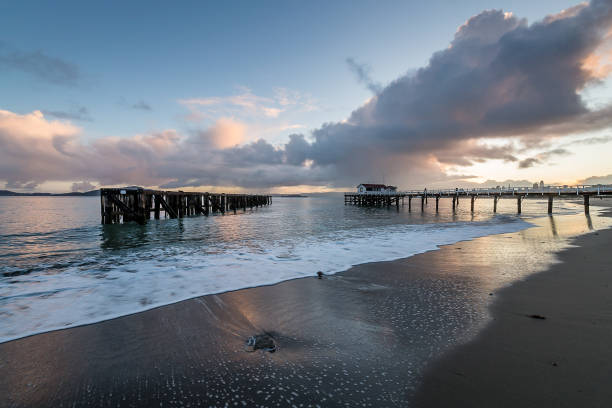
[{"xmin": 416, "ymin": 218, "xmax": 612, "ymax": 407}]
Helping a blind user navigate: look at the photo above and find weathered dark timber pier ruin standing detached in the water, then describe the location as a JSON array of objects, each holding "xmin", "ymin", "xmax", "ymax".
[{"xmin": 100, "ymin": 187, "xmax": 272, "ymax": 224}]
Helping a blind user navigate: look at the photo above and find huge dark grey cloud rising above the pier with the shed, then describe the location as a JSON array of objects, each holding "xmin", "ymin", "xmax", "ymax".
[{"xmin": 280, "ymin": 0, "xmax": 612, "ymax": 185}]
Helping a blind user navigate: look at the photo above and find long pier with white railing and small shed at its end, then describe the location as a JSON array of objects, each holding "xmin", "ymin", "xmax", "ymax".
[{"xmin": 344, "ymin": 185, "xmax": 612, "ymax": 214}]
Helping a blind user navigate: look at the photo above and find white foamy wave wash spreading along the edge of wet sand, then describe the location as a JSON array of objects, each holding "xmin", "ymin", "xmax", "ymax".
[{"xmin": 0, "ymin": 218, "xmax": 531, "ymax": 342}]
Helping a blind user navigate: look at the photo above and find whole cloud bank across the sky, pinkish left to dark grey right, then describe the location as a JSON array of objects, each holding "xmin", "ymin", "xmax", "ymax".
[{"xmin": 0, "ymin": 0, "xmax": 612, "ymax": 188}]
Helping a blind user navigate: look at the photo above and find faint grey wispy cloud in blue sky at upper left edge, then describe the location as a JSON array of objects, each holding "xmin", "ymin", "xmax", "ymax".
[{"xmin": 0, "ymin": 43, "xmax": 81, "ymax": 85}]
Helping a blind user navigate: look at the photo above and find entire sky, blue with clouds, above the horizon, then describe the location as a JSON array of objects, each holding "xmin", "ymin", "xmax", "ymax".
[{"xmin": 0, "ymin": 0, "xmax": 612, "ymax": 192}]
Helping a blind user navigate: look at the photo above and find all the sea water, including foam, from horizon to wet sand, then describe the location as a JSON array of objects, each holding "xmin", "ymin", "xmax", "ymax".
[{"xmin": 0, "ymin": 194, "xmax": 582, "ymax": 342}]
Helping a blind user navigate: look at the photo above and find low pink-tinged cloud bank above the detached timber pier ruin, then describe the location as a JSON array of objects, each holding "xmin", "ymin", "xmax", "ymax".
[{"xmin": 0, "ymin": 110, "xmax": 333, "ymax": 189}]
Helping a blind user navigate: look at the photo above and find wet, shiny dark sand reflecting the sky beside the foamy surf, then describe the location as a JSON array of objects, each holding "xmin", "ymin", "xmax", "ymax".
[{"xmin": 0, "ymin": 209, "xmax": 612, "ymax": 407}]
